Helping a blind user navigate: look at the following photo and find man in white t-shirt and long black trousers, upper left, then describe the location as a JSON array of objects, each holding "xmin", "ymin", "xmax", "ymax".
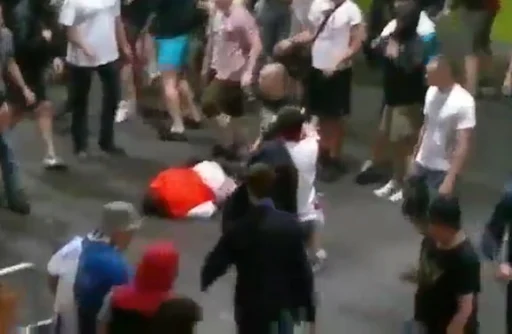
[{"xmin": 59, "ymin": 0, "xmax": 131, "ymax": 158}]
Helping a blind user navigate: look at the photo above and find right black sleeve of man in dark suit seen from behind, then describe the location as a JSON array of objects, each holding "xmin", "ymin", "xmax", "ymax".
[{"xmin": 289, "ymin": 221, "xmax": 316, "ymax": 322}]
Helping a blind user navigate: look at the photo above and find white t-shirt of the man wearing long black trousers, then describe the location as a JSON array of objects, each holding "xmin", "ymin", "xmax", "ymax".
[{"xmin": 59, "ymin": 0, "xmax": 121, "ymax": 67}]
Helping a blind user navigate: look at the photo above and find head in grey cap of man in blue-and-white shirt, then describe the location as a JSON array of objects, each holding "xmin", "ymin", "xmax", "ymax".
[{"xmin": 100, "ymin": 201, "xmax": 142, "ymax": 250}]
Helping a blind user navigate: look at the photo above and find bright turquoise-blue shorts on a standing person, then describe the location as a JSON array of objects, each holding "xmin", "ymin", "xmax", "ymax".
[{"xmin": 156, "ymin": 35, "xmax": 189, "ymax": 71}]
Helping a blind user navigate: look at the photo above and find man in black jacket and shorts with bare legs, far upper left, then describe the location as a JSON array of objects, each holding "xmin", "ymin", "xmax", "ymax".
[{"xmin": 1, "ymin": 0, "xmax": 66, "ymax": 170}]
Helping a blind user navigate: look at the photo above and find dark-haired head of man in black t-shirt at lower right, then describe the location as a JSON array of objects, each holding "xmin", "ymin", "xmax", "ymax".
[{"xmin": 428, "ymin": 196, "xmax": 462, "ymax": 244}]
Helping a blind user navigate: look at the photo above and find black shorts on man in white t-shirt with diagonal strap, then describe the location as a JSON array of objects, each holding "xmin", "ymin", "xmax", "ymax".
[{"xmin": 306, "ymin": 68, "xmax": 352, "ymax": 118}]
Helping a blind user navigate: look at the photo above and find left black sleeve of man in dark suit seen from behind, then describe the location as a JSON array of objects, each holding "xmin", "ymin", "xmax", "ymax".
[{"xmin": 201, "ymin": 230, "xmax": 233, "ymax": 291}]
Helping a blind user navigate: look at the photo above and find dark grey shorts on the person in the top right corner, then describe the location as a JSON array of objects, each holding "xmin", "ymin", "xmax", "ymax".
[{"xmin": 461, "ymin": 10, "xmax": 496, "ymax": 54}]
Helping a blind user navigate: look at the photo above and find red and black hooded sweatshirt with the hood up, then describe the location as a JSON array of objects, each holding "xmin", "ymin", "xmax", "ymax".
[{"xmin": 108, "ymin": 242, "xmax": 179, "ymax": 334}]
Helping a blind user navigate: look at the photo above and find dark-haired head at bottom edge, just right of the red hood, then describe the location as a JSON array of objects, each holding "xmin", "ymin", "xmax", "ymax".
[{"xmin": 151, "ymin": 297, "xmax": 203, "ymax": 334}]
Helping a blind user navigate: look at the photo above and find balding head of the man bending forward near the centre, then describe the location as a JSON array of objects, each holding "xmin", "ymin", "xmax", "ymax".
[{"xmin": 258, "ymin": 63, "xmax": 290, "ymax": 101}]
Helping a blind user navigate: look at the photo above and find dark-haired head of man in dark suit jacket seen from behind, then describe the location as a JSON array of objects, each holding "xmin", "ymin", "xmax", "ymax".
[{"xmin": 245, "ymin": 163, "xmax": 276, "ymax": 200}]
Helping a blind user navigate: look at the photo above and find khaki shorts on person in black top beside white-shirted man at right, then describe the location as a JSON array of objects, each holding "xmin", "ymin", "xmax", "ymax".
[{"xmin": 379, "ymin": 104, "xmax": 423, "ymax": 142}]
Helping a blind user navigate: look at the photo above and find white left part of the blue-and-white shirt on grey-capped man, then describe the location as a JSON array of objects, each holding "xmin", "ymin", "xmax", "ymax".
[{"xmin": 47, "ymin": 237, "xmax": 84, "ymax": 334}]
